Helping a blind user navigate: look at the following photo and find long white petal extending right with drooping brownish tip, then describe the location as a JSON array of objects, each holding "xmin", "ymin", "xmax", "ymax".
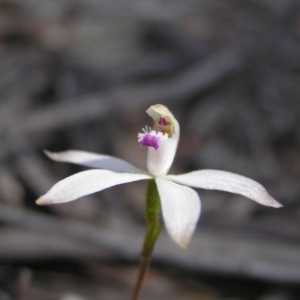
[{"xmin": 166, "ymin": 170, "xmax": 282, "ymax": 207}]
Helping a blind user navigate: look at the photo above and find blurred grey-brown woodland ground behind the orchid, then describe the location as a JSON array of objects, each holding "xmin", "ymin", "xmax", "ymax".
[{"xmin": 0, "ymin": 0, "xmax": 300, "ymax": 300}]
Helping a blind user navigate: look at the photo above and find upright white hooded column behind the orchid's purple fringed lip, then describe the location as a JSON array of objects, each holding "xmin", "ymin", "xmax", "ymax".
[{"xmin": 146, "ymin": 104, "xmax": 180, "ymax": 176}]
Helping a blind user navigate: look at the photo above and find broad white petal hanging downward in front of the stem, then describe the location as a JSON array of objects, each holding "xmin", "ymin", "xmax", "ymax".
[{"xmin": 156, "ymin": 178, "xmax": 201, "ymax": 248}]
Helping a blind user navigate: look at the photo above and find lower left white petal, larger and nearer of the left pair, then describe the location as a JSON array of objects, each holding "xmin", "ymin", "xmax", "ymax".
[{"xmin": 36, "ymin": 170, "xmax": 151, "ymax": 205}]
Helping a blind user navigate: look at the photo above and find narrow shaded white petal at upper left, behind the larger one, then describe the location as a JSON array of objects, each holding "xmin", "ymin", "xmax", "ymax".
[{"xmin": 45, "ymin": 150, "xmax": 146, "ymax": 174}]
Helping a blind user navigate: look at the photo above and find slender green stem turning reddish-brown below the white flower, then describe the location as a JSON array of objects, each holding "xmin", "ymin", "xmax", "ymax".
[{"xmin": 132, "ymin": 179, "xmax": 161, "ymax": 300}]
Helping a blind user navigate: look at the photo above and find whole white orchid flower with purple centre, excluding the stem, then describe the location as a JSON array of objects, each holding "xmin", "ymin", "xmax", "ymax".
[{"xmin": 37, "ymin": 104, "xmax": 282, "ymax": 248}]
